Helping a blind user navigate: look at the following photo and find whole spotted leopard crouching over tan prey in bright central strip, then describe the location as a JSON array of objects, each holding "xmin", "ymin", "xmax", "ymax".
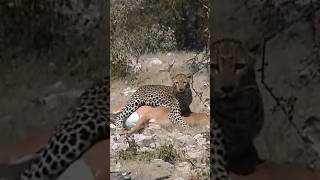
[{"xmin": 115, "ymin": 73, "xmax": 192, "ymax": 129}]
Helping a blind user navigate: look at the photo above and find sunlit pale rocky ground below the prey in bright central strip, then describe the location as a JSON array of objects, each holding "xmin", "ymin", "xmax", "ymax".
[{"xmin": 110, "ymin": 127, "xmax": 210, "ymax": 180}]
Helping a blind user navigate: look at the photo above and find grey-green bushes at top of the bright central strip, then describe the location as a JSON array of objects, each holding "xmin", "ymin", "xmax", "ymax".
[{"xmin": 110, "ymin": 0, "xmax": 209, "ymax": 79}]
